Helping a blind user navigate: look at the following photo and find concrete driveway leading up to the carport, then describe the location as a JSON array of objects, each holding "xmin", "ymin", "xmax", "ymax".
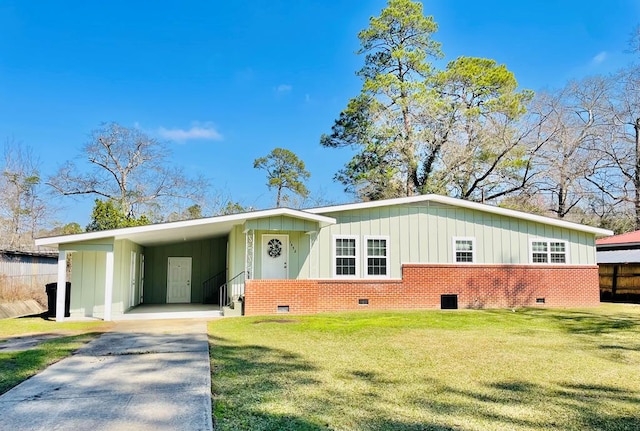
[{"xmin": 0, "ymin": 320, "xmax": 212, "ymax": 431}]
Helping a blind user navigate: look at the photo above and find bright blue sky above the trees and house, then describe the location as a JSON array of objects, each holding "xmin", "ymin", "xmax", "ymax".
[{"xmin": 0, "ymin": 0, "xmax": 640, "ymax": 226}]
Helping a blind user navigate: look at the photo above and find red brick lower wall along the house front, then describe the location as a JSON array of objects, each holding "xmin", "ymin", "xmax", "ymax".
[{"xmin": 245, "ymin": 264, "xmax": 600, "ymax": 316}]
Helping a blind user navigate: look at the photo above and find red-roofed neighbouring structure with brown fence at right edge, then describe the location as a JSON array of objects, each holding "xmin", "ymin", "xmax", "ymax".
[{"xmin": 596, "ymin": 230, "xmax": 640, "ymax": 302}]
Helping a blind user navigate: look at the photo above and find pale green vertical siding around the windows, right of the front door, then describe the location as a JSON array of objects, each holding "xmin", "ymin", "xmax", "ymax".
[{"xmin": 311, "ymin": 204, "xmax": 596, "ymax": 279}]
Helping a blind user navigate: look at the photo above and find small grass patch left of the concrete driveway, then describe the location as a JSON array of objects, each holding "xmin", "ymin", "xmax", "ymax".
[{"xmin": 0, "ymin": 318, "xmax": 109, "ymax": 394}]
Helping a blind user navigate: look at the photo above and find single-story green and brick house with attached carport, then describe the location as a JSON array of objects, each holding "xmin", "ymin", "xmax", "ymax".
[{"xmin": 36, "ymin": 194, "xmax": 612, "ymax": 320}]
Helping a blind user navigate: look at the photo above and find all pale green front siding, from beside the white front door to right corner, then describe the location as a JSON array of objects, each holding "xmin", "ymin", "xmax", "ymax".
[{"xmin": 229, "ymin": 203, "xmax": 595, "ymax": 279}]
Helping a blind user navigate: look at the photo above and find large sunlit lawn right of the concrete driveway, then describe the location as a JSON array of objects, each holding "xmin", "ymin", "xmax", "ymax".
[{"xmin": 209, "ymin": 304, "xmax": 640, "ymax": 431}]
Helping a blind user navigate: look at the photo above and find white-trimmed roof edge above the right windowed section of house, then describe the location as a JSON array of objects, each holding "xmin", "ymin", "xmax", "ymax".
[{"xmin": 305, "ymin": 194, "xmax": 613, "ymax": 236}]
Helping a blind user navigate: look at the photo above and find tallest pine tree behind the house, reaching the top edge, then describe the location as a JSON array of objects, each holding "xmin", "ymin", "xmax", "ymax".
[{"xmin": 321, "ymin": 0, "xmax": 442, "ymax": 199}]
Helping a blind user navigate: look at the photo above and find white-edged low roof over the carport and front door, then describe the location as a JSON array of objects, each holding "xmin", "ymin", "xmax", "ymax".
[{"xmin": 36, "ymin": 208, "xmax": 336, "ymax": 246}]
